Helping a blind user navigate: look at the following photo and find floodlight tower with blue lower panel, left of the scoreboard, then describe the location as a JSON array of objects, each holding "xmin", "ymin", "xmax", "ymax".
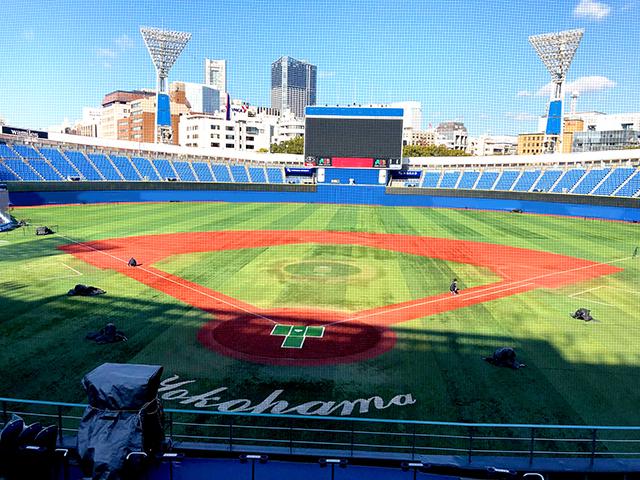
[{"xmin": 140, "ymin": 27, "xmax": 191, "ymax": 143}]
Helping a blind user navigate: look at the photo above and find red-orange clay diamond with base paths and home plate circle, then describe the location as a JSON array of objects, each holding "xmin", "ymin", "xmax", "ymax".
[{"xmin": 60, "ymin": 230, "xmax": 621, "ymax": 366}]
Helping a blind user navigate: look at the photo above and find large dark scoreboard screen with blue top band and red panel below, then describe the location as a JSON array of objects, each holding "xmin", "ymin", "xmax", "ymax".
[{"xmin": 304, "ymin": 107, "xmax": 404, "ymax": 169}]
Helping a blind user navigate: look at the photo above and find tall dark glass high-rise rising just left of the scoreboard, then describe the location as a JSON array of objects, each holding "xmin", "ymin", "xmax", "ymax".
[{"xmin": 271, "ymin": 56, "xmax": 317, "ymax": 117}]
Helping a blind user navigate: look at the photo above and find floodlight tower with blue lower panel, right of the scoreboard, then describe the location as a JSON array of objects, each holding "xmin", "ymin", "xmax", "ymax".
[{"xmin": 529, "ymin": 29, "xmax": 584, "ymax": 153}]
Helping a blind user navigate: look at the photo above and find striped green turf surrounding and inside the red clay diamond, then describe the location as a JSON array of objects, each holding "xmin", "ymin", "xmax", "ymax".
[{"xmin": 0, "ymin": 203, "xmax": 640, "ymax": 425}]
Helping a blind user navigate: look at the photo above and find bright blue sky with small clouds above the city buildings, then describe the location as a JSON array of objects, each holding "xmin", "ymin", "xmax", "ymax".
[{"xmin": 0, "ymin": 0, "xmax": 640, "ymax": 135}]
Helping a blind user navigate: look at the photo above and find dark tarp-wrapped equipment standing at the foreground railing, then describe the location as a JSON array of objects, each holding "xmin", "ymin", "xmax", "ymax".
[{"xmin": 78, "ymin": 363, "xmax": 163, "ymax": 480}]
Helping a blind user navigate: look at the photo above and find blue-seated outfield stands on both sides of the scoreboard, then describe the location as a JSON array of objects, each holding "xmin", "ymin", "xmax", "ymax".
[{"xmin": 0, "ymin": 131, "xmax": 640, "ymax": 201}]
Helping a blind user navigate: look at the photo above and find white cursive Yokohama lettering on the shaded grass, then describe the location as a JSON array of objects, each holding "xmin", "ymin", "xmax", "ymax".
[{"xmin": 158, "ymin": 375, "xmax": 416, "ymax": 416}]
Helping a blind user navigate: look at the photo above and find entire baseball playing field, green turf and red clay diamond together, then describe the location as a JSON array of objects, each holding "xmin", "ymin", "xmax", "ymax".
[{"xmin": 0, "ymin": 203, "xmax": 640, "ymax": 425}]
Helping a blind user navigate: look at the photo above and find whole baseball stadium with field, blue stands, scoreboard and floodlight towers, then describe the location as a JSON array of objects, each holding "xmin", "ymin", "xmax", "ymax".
[{"xmin": 0, "ymin": 5, "xmax": 640, "ymax": 480}]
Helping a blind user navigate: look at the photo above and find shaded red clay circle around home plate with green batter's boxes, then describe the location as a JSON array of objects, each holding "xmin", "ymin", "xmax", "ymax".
[{"xmin": 198, "ymin": 310, "xmax": 396, "ymax": 366}]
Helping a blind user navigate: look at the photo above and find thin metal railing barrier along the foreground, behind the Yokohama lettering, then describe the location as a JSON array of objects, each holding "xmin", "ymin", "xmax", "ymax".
[{"xmin": 0, "ymin": 398, "xmax": 640, "ymax": 466}]
